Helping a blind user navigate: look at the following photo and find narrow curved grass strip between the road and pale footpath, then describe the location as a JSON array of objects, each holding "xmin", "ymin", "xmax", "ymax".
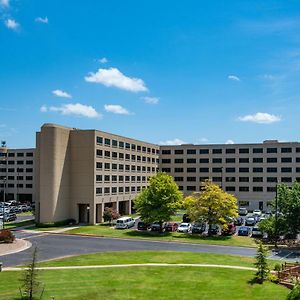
[{"xmin": 39, "ymin": 251, "xmax": 276, "ymax": 267}]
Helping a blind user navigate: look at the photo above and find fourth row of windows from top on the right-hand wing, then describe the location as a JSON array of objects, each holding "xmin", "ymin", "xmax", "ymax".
[{"xmin": 174, "ymin": 176, "xmax": 300, "ymax": 183}]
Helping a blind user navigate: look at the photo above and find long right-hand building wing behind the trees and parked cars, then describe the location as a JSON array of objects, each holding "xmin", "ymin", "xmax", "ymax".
[{"xmin": 159, "ymin": 140, "xmax": 300, "ymax": 210}]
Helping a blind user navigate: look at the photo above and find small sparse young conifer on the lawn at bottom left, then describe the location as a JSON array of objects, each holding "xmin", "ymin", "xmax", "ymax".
[{"xmin": 21, "ymin": 247, "xmax": 40, "ymax": 300}]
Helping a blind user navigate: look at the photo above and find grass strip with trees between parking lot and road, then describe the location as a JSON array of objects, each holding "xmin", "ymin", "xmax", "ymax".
[{"xmin": 66, "ymin": 224, "xmax": 256, "ymax": 247}]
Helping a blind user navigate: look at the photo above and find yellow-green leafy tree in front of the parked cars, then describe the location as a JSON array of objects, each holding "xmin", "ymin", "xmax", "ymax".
[{"xmin": 184, "ymin": 180, "xmax": 238, "ymax": 232}]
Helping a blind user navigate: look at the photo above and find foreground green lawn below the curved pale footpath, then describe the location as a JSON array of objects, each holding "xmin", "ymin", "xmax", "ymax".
[{"xmin": 0, "ymin": 267, "xmax": 289, "ymax": 300}]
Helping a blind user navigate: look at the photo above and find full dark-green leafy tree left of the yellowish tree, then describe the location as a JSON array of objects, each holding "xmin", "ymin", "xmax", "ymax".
[{"xmin": 134, "ymin": 172, "xmax": 182, "ymax": 231}]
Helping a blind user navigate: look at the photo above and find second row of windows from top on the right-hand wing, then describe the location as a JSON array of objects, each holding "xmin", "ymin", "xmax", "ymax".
[{"xmin": 161, "ymin": 157, "xmax": 300, "ymax": 164}]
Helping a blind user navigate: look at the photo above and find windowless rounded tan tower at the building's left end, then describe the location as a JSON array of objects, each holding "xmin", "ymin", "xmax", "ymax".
[{"xmin": 36, "ymin": 124, "xmax": 72, "ymax": 223}]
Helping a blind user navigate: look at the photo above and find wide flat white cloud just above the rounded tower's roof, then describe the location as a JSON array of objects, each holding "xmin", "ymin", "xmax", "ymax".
[{"xmin": 40, "ymin": 103, "xmax": 102, "ymax": 119}]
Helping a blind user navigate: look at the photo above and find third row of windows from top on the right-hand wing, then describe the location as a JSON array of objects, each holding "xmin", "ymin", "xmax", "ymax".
[{"xmin": 161, "ymin": 167, "xmax": 300, "ymax": 173}]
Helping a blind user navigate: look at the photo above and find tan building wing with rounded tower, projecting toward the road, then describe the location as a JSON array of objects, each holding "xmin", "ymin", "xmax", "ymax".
[{"xmin": 36, "ymin": 124, "xmax": 159, "ymax": 224}]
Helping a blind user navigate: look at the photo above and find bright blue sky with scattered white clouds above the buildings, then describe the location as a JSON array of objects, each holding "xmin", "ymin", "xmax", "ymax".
[{"xmin": 0, "ymin": 0, "xmax": 300, "ymax": 148}]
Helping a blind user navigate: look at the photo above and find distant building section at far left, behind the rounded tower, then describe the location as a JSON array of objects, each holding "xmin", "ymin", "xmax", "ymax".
[{"xmin": 0, "ymin": 147, "xmax": 35, "ymax": 202}]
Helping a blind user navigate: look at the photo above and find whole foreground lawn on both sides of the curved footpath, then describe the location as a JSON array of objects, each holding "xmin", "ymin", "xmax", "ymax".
[{"xmin": 0, "ymin": 251, "xmax": 289, "ymax": 300}]
